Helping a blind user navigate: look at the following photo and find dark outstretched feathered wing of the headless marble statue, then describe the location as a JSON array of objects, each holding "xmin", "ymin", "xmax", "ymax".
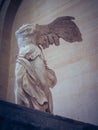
[{"xmin": 34, "ymin": 16, "xmax": 82, "ymax": 49}]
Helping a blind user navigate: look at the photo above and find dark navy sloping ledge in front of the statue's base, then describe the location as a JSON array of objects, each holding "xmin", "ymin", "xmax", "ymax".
[{"xmin": 0, "ymin": 101, "xmax": 98, "ymax": 130}]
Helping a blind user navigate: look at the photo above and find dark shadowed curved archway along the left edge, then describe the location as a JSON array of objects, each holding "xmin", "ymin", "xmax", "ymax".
[{"xmin": 0, "ymin": 0, "xmax": 21, "ymax": 100}]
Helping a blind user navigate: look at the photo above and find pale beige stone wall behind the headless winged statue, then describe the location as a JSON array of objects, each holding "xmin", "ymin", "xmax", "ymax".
[{"xmin": 8, "ymin": 0, "xmax": 98, "ymax": 125}]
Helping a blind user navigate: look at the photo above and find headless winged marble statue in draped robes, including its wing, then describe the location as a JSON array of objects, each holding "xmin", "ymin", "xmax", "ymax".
[{"xmin": 15, "ymin": 16, "xmax": 82, "ymax": 113}]
